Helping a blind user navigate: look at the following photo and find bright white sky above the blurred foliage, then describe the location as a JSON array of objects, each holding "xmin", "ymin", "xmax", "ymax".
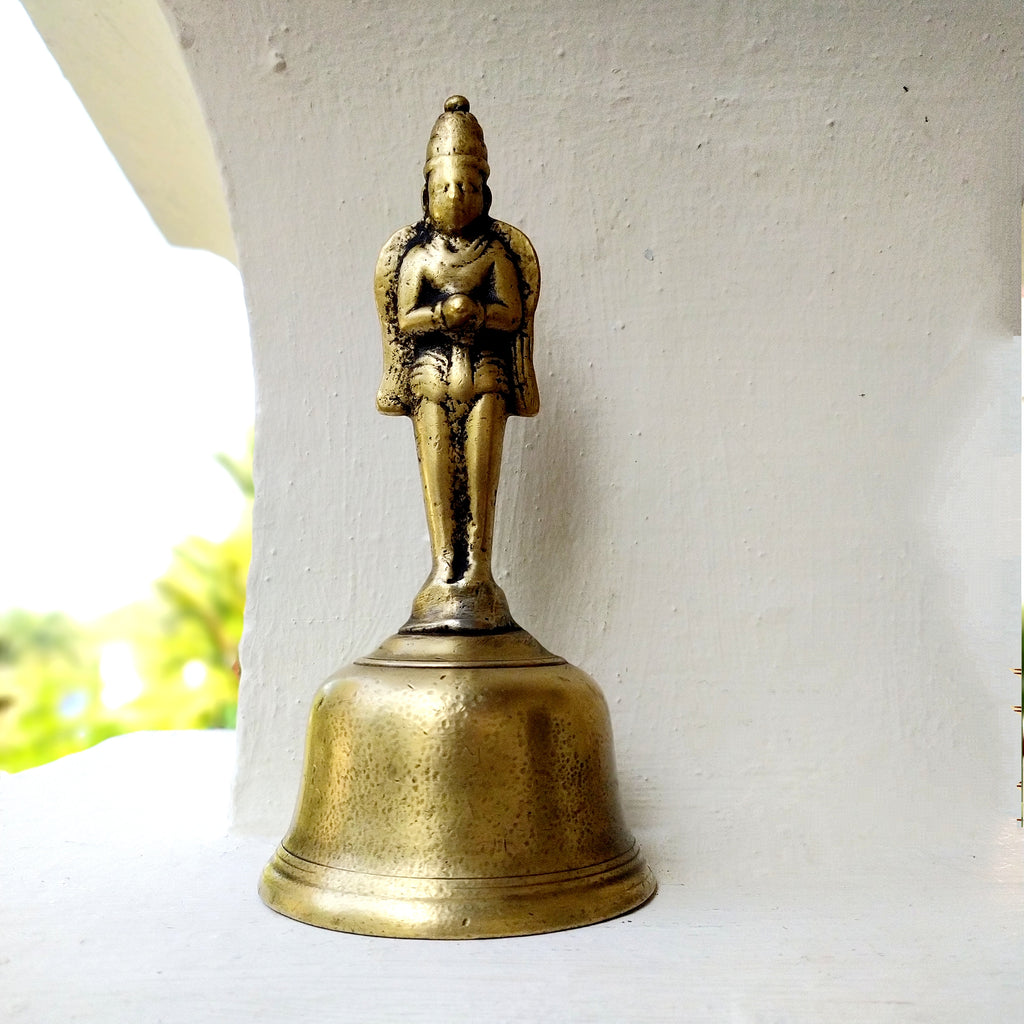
[{"xmin": 0, "ymin": 0, "xmax": 253, "ymax": 617}]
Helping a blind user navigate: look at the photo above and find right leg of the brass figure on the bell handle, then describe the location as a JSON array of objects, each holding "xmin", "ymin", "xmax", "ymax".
[{"xmin": 466, "ymin": 393, "xmax": 508, "ymax": 581}]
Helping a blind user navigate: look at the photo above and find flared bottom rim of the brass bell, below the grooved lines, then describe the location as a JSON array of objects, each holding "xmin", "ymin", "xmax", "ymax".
[{"xmin": 259, "ymin": 844, "xmax": 655, "ymax": 939}]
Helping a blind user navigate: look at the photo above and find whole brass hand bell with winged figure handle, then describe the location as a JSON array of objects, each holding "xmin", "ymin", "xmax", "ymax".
[{"xmin": 260, "ymin": 96, "xmax": 654, "ymax": 938}]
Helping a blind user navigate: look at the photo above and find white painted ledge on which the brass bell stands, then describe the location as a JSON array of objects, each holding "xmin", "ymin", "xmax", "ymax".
[{"xmin": 0, "ymin": 732, "xmax": 1024, "ymax": 1024}]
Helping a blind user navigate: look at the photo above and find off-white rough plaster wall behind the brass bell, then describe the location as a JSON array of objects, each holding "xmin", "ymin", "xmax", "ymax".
[{"xmin": 168, "ymin": 0, "xmax": 1024, "ymax": 881}]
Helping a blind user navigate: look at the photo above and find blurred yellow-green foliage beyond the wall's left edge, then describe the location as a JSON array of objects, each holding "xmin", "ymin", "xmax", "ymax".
[{"xmin": 0, "ymin": 449, "xmax": 253, "ymax": 771}]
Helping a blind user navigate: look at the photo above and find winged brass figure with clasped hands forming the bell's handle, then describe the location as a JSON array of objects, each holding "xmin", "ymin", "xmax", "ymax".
[{"xmin": 374, "ymin": 96, "xmax": 541, "ymax": 633}]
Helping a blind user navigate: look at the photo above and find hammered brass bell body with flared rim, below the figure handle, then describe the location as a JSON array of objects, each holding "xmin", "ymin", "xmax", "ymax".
[{"xmin": 260, "ymin": 629, "xmax": 655, "ymax": 939}]
